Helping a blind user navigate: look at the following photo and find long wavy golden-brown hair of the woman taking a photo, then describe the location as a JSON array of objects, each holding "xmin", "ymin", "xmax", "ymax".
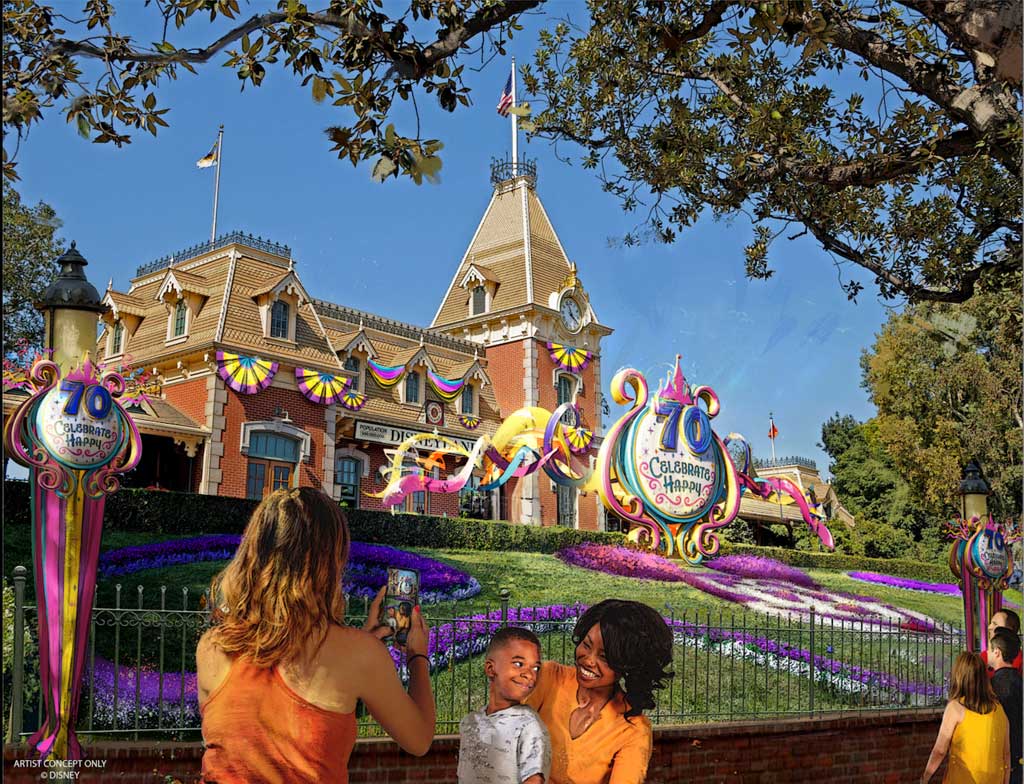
[{"xmin": 210, "ymin": 487, "xmax": 349, "ymax": 666}]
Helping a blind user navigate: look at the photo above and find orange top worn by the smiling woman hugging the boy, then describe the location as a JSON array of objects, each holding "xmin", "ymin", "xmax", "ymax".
[{"xmin": 526, "ymin": 661, "xmax": 653, "ymax": 784}]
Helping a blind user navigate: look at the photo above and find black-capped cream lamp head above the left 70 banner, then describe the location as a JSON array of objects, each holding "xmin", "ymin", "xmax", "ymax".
[{"xmin": 36, "ymin": 242, "xmax": 106, "ymax": 373}]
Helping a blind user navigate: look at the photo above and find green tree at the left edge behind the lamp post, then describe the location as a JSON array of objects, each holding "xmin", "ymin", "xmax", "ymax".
[{"xmin": 3, "ymin": 182, "xmax": 65, "ymax": 357}]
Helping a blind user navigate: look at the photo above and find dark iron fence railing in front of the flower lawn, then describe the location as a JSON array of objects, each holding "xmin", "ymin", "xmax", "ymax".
[{"xmin": 8, "ymin": 567, "xmax": 964, "ymax": 739}]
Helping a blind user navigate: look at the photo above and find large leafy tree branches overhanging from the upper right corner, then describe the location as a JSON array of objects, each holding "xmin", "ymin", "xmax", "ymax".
[{"xmin": 524, "ymin": 0, "xmax": 1021, "ymax": 302}]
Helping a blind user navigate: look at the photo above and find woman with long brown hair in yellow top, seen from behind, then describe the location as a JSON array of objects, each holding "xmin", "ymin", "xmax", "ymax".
[{"xmin": 921, "ymin": 653, "xmax": 1010, "ymax": 784}]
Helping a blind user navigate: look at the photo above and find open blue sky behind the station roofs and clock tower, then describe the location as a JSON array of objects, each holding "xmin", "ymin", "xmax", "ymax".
[{"xmin": 8, "ymin": 2, "xmax": 888, "ymax": 478}]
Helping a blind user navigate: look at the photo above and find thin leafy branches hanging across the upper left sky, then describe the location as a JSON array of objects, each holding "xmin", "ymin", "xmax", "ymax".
[{"xmin": 3, "ymin": 0, "xmax": 542, "ymax": 182}]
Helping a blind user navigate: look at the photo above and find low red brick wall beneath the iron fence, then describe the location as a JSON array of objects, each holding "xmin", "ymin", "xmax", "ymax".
[{"xmin": 4, "ymin": 709, "xmax": 942, "ymax": 784}]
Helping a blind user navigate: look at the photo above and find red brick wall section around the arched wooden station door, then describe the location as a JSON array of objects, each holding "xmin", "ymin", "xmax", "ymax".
[{"xmin": 218, "ymin": 378, "xmax": 326, "ymax": 497}]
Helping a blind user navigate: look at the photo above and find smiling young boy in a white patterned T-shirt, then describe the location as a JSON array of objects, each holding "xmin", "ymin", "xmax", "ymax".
[{"xmin": 459, "ymin": 626, "xmax": 551, "ymax": 784}]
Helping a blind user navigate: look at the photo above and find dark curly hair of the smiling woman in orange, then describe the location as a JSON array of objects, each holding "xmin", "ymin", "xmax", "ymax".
[{"xmin": 572, "ymin": 599, "xmax": 672, "ymax": 718}]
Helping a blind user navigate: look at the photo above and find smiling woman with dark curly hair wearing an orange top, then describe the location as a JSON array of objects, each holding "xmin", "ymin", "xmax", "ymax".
[{"xmin": 525, "ymin": 599, "xmax": 672, "ymax": 784}]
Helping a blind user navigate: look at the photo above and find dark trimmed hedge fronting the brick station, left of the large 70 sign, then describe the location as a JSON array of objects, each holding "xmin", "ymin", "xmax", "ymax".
[{"xmin": 3, "ymin": 481, "xmax": 626, "ymax": 553}]
